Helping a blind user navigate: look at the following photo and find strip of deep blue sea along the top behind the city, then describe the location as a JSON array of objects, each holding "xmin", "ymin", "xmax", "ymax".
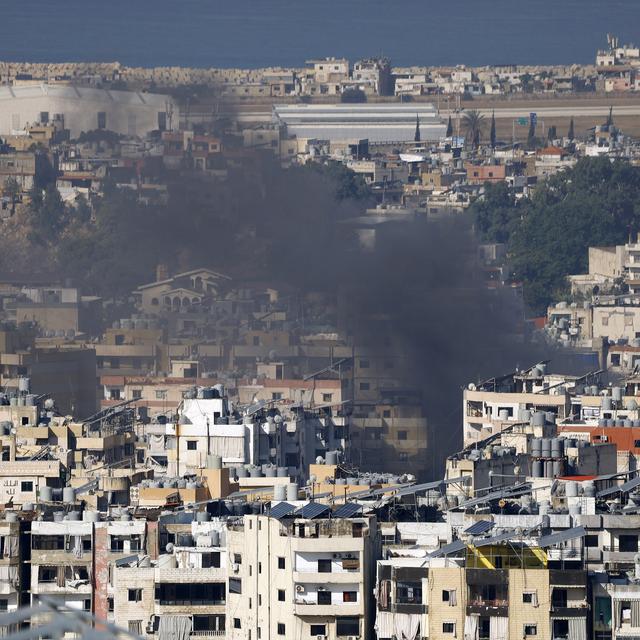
[{"xmin": 0, "ymin": 0, "xmax": 640, "ymax": 67}]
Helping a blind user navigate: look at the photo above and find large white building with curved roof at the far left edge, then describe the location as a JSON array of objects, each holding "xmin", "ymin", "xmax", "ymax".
[{"xmin": 0, "ymin": 84, "xmax": 178, "ymax": 138}]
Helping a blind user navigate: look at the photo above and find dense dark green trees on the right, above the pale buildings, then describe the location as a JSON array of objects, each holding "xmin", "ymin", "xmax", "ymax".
[{"xmin": 472, "ymin": 158, "xmax": 640, "ymax": 313}]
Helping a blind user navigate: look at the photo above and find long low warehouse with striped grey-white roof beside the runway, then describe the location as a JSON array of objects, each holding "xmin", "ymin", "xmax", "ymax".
[{"xmin": 273, "ymin": 103, "xmax": 447, "ymax": 143}]
